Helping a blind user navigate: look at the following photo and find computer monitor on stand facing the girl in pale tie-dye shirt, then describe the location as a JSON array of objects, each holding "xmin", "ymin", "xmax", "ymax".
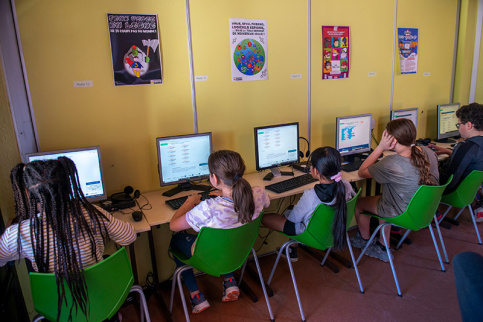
[{"xmin": 156, "ymin": 132, "xmax": 212, "ymax": 197}]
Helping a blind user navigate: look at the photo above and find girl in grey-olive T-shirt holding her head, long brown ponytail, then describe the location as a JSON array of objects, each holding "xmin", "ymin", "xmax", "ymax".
[{"xmin": 351, "ymin": 118, "xmax": 439, "ymax": 262}]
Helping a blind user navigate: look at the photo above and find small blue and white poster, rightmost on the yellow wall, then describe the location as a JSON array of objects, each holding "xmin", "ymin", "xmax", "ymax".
[{"xmin": 397, "ymin": 28, "xmax": 419, "ymax": 74}]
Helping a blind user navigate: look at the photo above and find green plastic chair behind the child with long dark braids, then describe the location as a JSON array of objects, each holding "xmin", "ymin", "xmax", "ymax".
[{"xmin": 29, "ymin": 247, "xmax": 151, "ymax": 322}]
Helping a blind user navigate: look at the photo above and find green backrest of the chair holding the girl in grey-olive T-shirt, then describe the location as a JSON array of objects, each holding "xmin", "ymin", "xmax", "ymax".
[{"xmin": 384, "ymin": 176, "xmax": 453, "ymax": 231}]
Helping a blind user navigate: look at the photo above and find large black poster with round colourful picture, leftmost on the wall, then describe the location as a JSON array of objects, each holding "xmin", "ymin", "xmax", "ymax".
[{"xmin": 107, "ymin": 13, "xmax": 163, "ymax": 86}]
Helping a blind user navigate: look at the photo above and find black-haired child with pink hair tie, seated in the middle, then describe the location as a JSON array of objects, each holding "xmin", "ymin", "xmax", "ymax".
[{"xmin": 262, "ymin": 147, "xmax": 355, "ymax": 262}]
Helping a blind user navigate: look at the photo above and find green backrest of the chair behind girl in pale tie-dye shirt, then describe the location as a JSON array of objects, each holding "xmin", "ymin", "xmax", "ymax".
[{"xmin": 189, "ymin": 212, "xmax": 263, "ymax": 276}]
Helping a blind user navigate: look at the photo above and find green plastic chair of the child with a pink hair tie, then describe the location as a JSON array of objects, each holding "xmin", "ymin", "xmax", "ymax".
[{"xmin": 268, "ymin": 189, "xmax": 364, "ymax": 321}]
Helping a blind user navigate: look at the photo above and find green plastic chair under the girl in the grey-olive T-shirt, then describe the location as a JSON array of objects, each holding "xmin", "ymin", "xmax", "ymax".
[{"xmin": 356, "ymin": 176, "xmax": 453, "ymax": 296}]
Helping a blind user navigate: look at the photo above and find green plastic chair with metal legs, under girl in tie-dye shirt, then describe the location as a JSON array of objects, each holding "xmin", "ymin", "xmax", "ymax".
[{"xmin": 169, "ymin": 212, "xmax": 274, "ymax": 321}]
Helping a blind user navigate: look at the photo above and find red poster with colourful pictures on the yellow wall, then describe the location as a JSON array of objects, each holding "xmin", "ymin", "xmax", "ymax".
[{"xmin": 322, "ymin": 26, "xmax": 350, "ymax": 79}]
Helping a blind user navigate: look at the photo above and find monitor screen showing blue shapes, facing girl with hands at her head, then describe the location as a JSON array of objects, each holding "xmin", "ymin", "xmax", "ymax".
[{"xmin": 336, "ymin": 114, "xmax": 372, "ymax": 155}]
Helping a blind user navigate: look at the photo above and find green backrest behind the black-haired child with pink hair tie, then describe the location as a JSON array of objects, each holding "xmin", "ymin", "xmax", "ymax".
[{"xmin": 289, "ymin": 189, "xmax": 361, "ymax": 250}]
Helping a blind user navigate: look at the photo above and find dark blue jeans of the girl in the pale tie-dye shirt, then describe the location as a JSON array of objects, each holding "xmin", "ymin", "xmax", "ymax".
[{"xmin": 170, "ymin": 232, "xmax": 233, "ymax": 293}]
